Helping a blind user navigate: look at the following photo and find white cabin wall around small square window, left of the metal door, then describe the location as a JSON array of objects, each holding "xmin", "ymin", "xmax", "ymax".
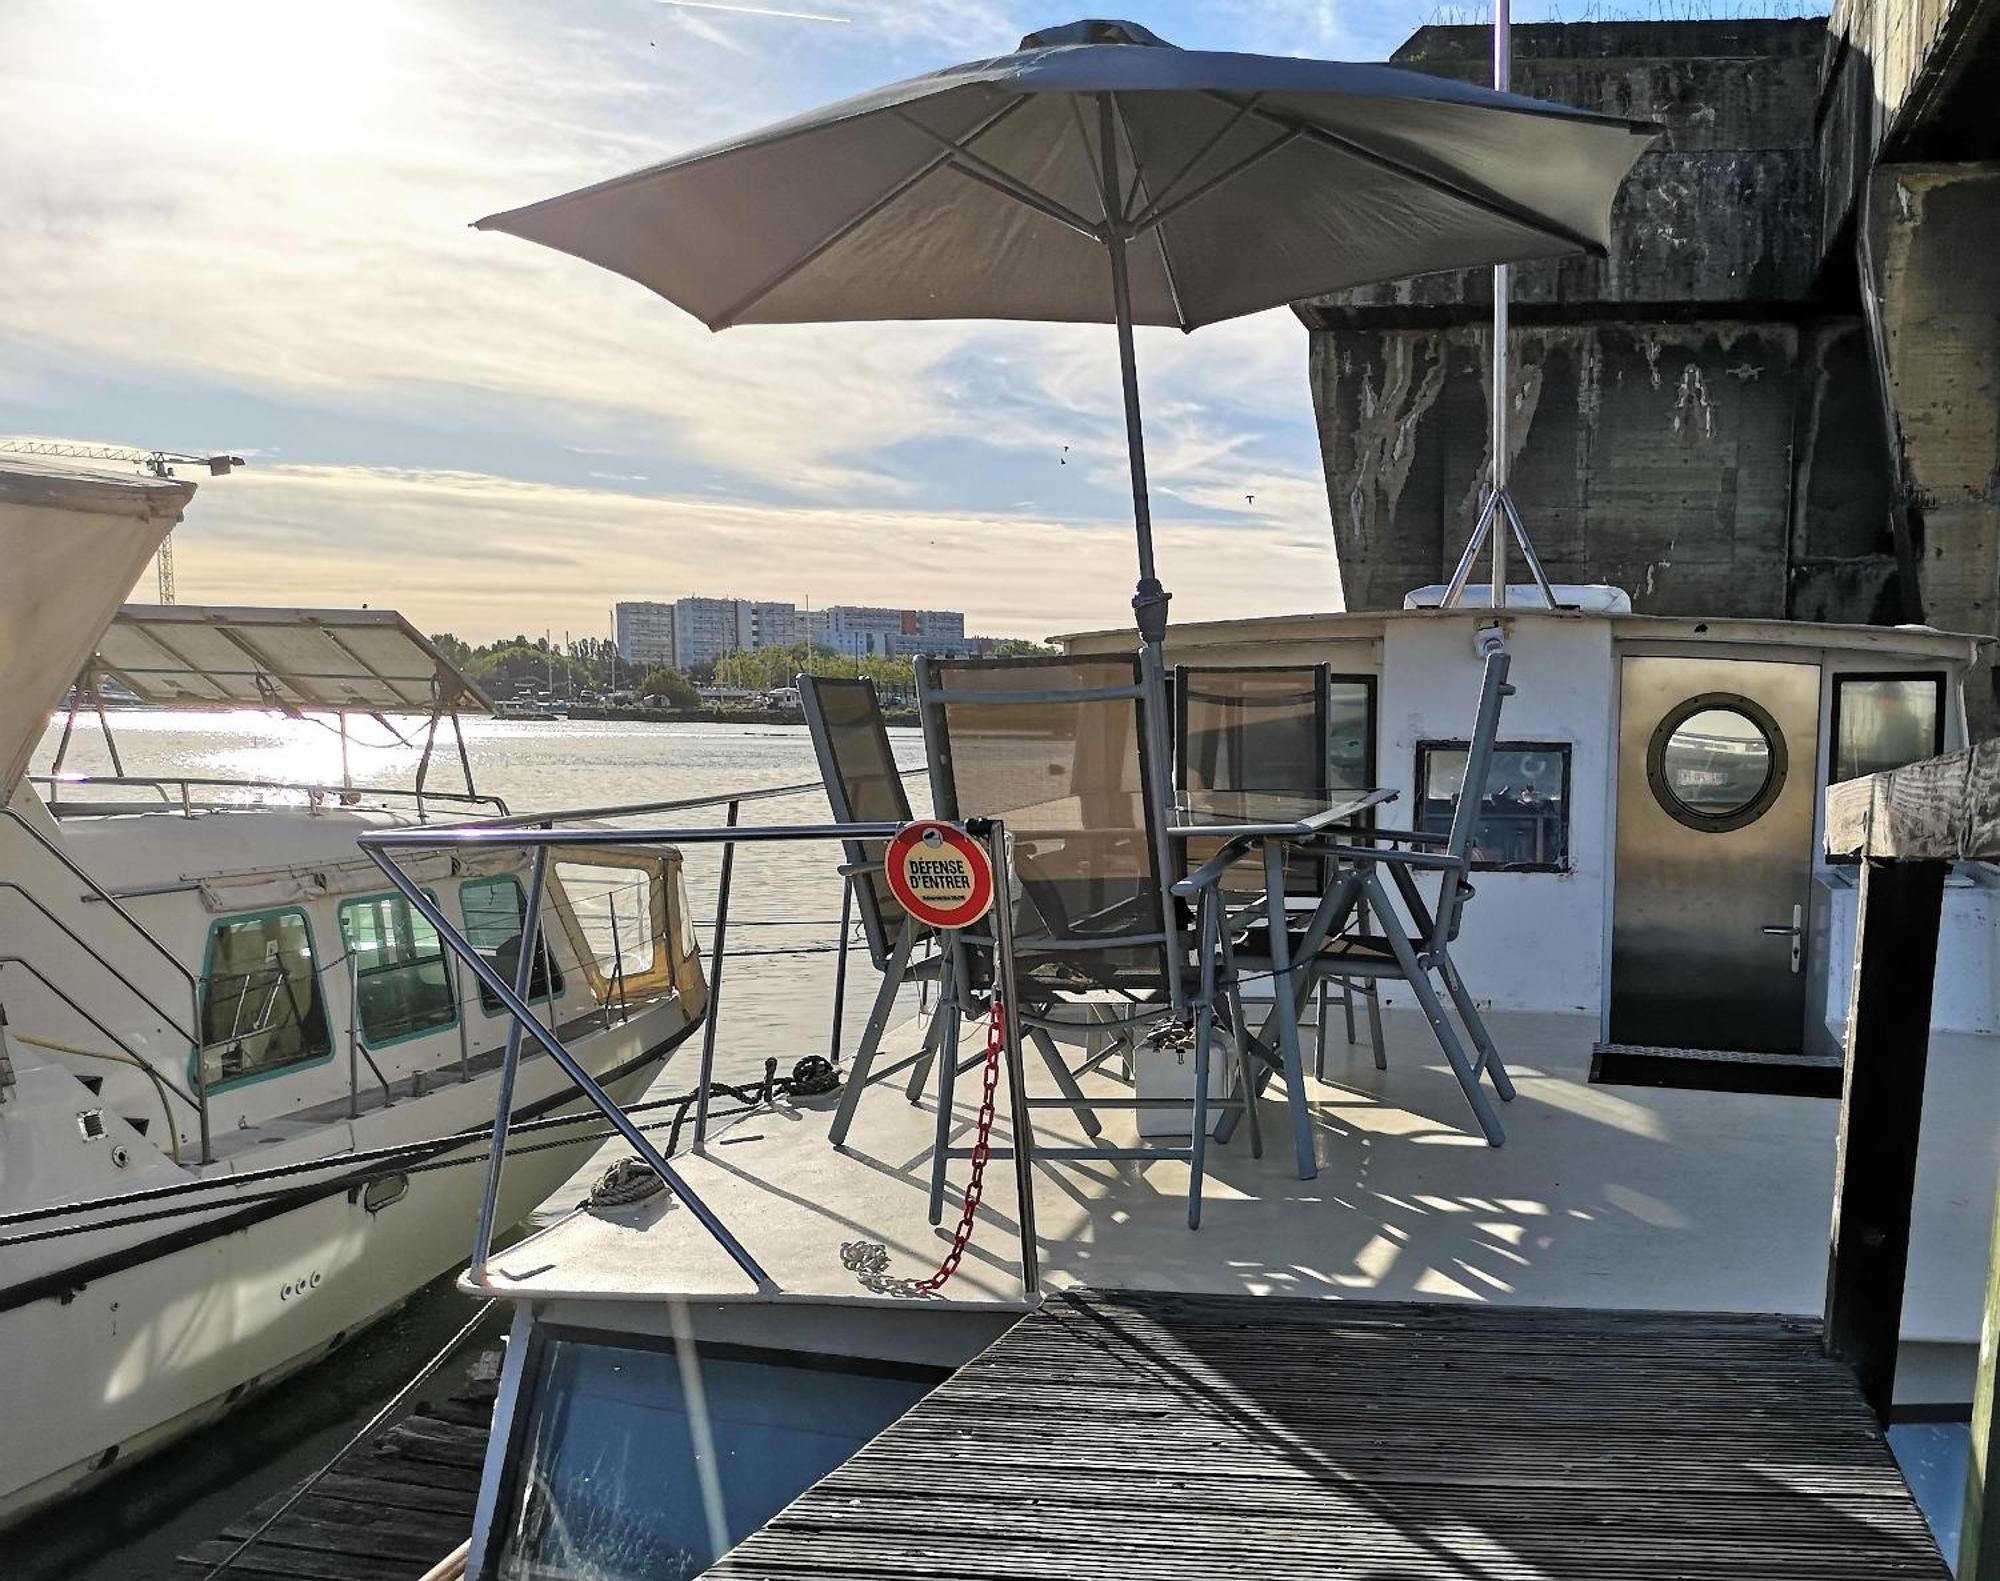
[{"xmin": 1376, "ymin": 616, "xmax": 1616, "ymax": 1015}]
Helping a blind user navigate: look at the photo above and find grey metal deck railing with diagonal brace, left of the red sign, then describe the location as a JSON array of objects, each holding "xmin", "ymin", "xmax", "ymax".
[{"xmin": 360, "ymin": 812, "xmax": 1038, "ymax": 1295}]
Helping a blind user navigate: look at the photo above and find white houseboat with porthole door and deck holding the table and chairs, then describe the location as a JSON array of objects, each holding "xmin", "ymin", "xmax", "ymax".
[{"xmin": 360, "ymin": 588, "xmax": 2000, "ymax": 1581}]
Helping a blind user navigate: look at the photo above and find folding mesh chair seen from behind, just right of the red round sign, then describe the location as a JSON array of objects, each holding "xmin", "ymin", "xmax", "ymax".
[{"xmin": 916, "ymin": 656, "xmax": 1260, "ymax": 1229}]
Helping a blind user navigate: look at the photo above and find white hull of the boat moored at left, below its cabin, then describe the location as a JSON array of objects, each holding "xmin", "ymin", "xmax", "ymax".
[{"xmin": 0, "ymin": 1001, "xmax": 688, "ymax": 1525}]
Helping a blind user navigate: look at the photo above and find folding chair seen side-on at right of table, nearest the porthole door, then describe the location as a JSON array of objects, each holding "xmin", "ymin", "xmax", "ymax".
[{"xmin": 1224, "ymin": 648, "xmax": 1514, "ymax": 1147}]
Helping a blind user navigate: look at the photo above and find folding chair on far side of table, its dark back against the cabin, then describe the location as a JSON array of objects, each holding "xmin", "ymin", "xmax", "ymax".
[{"xmin": 1174, "ymin": 664, "xmax": 1388, "ymax": 1081}]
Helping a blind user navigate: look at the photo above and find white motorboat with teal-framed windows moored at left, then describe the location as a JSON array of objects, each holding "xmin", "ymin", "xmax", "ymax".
[{"xmin": 0, "ymin": 470, "xmax": 706, "ymax": 1523}]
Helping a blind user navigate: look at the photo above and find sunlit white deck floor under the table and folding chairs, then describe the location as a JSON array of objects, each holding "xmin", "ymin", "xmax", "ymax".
[{"xmin": 476, "ymin": 1013, "xmax": 2000, "ymax": 1384}]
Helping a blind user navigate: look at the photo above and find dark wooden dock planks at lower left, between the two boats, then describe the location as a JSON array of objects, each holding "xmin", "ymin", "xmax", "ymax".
[{"xmin": 178, "ymin": 1369, "xmax": 494, "ymax": 1581}]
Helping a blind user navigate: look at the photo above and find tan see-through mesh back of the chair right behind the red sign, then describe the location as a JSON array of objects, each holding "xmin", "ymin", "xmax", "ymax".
[{"xmin": 918, "ymin": 656, "xmax": 1178, "ymax": 993}]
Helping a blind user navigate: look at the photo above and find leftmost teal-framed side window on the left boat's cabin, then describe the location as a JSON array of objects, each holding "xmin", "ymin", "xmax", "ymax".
[{"xmin": 200, "ymin": 911, "xmax": 332, "ymax": 1091}]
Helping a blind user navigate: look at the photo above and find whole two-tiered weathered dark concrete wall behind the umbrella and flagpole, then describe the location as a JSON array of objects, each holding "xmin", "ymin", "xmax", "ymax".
[{"xmin": 1300, "ymin": 20, "xmax": 1900, "ymax": 620}]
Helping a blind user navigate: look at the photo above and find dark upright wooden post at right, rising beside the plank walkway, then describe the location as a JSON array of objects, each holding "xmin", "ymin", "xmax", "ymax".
[{"xmin": 1826, "ymin": 860, "xmax": 1950, "ymax": 1425}]
